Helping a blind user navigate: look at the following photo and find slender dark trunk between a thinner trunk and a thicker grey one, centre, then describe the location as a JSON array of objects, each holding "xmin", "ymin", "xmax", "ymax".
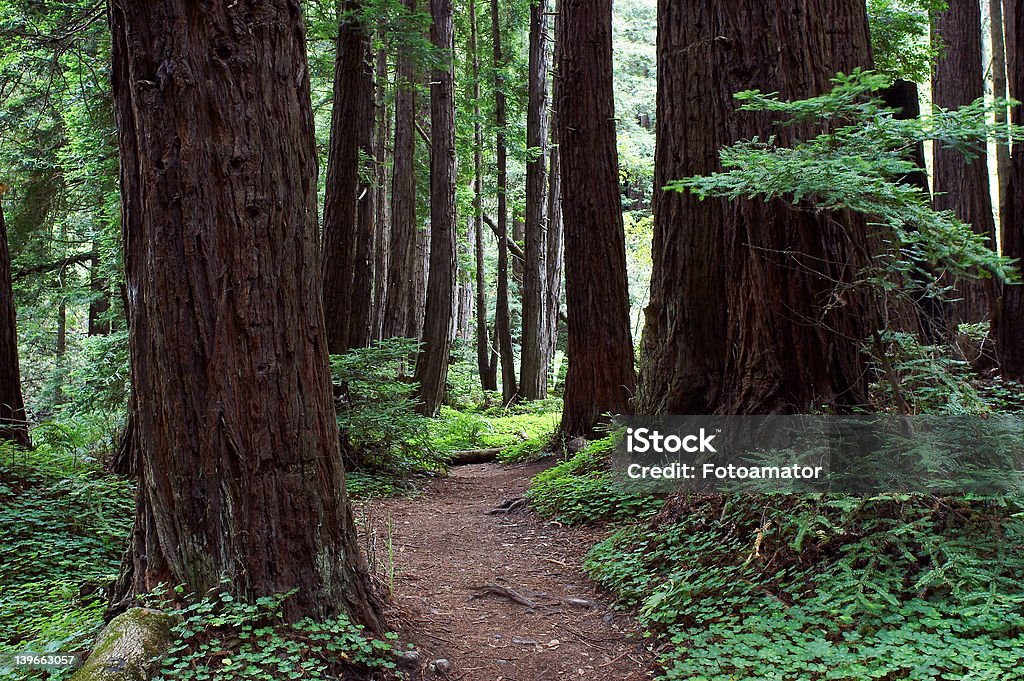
[{"xmin": 490, "ymin": 0, "xmax": 519, "ymax": 405}]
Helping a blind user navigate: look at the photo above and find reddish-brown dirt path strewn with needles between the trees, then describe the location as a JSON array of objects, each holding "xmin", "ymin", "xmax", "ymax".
[{"xmin": 361, "ymin": 464, "xmax": 652, "ymax": 681}]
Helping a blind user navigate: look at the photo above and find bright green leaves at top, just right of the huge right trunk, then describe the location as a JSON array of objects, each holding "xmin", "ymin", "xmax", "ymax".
[{"xmin": 867, "ymin": 0, "xmax": 946, "ymax": 83}]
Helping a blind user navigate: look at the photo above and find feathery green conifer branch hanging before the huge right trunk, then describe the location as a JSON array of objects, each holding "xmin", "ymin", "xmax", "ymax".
[{"xmin": 668, "ymin": 70, "xmax": 1022, "ymax": 311}]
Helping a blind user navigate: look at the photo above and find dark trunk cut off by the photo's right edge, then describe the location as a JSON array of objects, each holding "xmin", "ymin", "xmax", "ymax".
[{"xmin": 993, "ymin": 0, "xmax": 1024, "ymax": 381}]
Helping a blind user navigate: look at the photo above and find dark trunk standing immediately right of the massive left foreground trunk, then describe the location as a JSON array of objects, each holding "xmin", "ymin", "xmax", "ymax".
[{"xmin": 323, "ymin": 0, "xmax": 375, "ymax": 354}]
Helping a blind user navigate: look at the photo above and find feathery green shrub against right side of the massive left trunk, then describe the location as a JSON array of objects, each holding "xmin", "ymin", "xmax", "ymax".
[{"xmin": 331, "ymin": 338, "xmax": 443, "ymax": 483}]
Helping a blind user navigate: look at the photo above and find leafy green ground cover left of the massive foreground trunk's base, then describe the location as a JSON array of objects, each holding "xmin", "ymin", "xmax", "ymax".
[{"xmin": 0, "ymin": 424, "xmax": 135, "ymax": 679}]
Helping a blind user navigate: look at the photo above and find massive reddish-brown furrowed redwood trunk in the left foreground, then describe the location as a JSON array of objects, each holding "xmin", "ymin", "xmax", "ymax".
[{"xmin": 110, "ymin": 0, "xmax": 382, "ymax": 631}]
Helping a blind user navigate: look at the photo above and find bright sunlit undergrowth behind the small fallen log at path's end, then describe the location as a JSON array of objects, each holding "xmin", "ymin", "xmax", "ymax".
[{"xmin": 430, "ymin": 398, "xmax": 562, "ymax": 463}]
